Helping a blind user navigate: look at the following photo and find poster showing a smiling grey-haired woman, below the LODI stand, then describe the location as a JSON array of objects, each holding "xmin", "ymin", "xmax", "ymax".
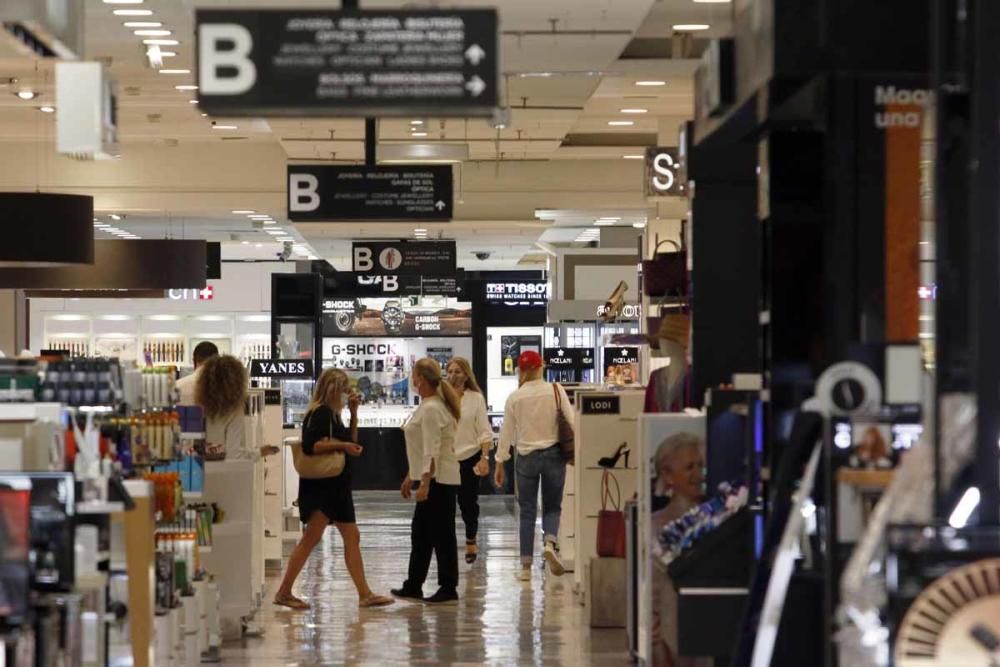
[{"xmin": 639, "ymin": 414, "xmax": 705, "ymax": 667}]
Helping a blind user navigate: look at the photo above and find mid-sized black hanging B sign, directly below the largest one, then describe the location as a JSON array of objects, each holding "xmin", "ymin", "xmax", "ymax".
[{"xmin": 288, "ymin": 165, "xmax": 454, "ymax": 222}]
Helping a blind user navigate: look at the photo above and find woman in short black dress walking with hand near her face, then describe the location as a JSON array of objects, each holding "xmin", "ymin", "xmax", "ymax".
[{"xmin": 274, "ymin": 368, "xmax": 393, "ymax": 609}]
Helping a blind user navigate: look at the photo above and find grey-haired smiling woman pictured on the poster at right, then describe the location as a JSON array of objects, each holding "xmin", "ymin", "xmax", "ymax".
[{"xmin": 650, "ymin": 433, "xmax": 712, "ymax": 667}]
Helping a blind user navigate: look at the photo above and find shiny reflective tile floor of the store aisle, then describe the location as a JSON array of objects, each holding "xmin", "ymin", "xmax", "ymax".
[{"xmin": 223, "ymin": 492, "xmax": 629, "ymax": 667}]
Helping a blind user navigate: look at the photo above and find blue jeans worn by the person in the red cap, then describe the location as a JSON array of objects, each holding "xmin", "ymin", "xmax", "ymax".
[{"xmin": 516, "ymin": 445, "xmax": 566, "ymax": 564}]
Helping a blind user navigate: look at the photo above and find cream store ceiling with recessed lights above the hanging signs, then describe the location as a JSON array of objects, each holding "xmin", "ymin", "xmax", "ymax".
[{"xmin": 0, "ymin": 0, "xmax": 731, "ymax": 268}]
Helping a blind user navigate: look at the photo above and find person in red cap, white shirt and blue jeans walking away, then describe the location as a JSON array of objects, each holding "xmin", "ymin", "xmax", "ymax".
[{"xmin": 494, "ymin": 351, "xmax": 573, "ymax": 581}]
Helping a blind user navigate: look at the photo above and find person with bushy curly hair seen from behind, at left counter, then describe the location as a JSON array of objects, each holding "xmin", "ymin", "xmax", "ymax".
[{"xmin": 195, "ymin": 354, "xmax": 278, "ymax": 459}]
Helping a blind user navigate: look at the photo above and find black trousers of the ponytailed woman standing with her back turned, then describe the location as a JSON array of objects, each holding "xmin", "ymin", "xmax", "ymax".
[{"xmin": 403, "ymin": 480, "xmax": 458, "ymax": 591}]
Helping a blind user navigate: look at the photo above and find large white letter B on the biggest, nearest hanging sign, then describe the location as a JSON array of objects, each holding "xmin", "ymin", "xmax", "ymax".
[{"xmin": 198, "ymin": 23, "xmax": 257, "ymax": 95}]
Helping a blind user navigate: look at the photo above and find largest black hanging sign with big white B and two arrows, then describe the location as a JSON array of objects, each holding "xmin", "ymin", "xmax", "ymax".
[{"xmin": 195, "ymin": 9, "xmax": 500, "ymax": 118}]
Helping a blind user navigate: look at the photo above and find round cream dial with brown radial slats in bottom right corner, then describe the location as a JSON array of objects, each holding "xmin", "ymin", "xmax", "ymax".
[{"xmin": 895, "ymin": 558, "xmax": 1000, "ymax": 667}]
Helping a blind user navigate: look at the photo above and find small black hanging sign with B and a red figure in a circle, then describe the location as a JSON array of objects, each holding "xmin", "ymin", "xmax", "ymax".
[{"xmin": 351, "ymin": 241, "xmax": 456, "ymax": 276}]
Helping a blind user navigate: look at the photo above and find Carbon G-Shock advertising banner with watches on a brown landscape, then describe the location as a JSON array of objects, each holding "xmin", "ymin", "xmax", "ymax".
[{"xmin": 323, "ymin": 298, "xmax": 472, "ymax": 338}]
